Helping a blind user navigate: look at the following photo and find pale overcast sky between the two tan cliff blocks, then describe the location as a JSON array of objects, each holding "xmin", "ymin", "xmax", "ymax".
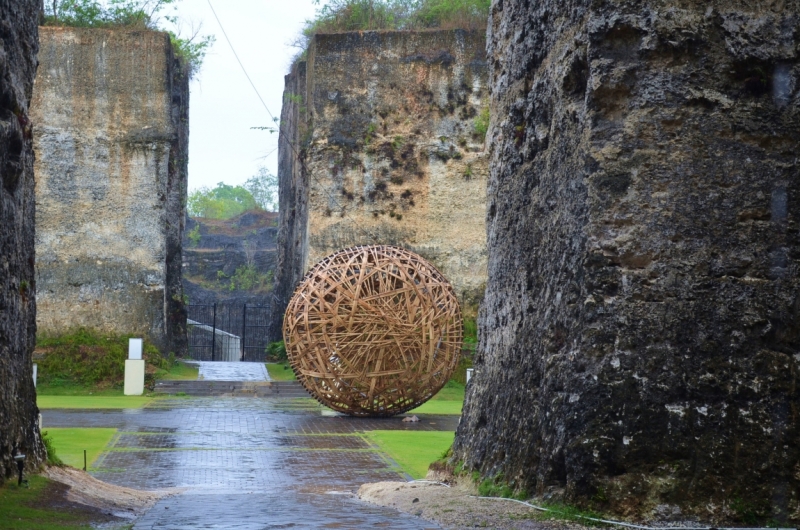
[{"xmin": 165, "ymin": 0, "xmax": 315, "ymax": 189}]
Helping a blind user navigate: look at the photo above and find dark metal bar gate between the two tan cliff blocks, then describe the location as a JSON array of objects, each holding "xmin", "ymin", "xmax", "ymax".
[{"xmin": 186, "ymin": 304, "xmax": 270, "ymax": 362}]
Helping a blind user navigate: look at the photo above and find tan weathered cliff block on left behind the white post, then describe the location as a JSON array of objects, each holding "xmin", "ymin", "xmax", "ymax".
[{"xmin": 32, "ymin": 27, "xmax": 189, "ymax": 353}]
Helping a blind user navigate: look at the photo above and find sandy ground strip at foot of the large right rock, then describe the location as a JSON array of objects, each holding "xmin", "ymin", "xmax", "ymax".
[{"xmin": 358, "ymin": 481, "xmax": 585, "ymax": 530}]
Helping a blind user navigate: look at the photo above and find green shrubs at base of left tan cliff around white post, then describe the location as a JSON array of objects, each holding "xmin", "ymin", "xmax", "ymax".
[{"xmin": 36, "ymin": 329, "xmax": 173, "ymax": 388}]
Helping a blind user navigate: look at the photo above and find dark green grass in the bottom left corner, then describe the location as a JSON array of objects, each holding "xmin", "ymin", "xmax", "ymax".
[{"xmin": 0, "ymin": 474, "xmax": 103, "ymax": 530}]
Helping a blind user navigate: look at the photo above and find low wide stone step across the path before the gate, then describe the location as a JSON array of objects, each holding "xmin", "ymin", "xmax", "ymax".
[{"xmin": 154, "ymin": 381, "xmax": 309, "ymax": 398}]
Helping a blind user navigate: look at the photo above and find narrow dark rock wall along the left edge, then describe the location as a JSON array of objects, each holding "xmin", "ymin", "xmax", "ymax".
[{"xmin": 0, "ymin": 0, "xmax": 44, "ymax": 482}]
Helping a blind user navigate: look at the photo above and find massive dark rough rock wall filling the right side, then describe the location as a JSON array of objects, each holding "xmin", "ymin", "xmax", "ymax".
[{"xmin": 455, "ymin": 0, "xmax": 800, "ymax": 522}]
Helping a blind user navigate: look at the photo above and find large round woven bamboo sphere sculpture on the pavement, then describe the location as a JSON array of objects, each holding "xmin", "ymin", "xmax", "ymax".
[{"xmin": 283, "ymin": 246, "xmax": 463, "ymax": 416}]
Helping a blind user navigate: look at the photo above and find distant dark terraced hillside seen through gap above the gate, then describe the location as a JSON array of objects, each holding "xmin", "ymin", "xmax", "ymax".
[{"xmin": 183, "ymin": 211, "xmax": 278, "ymax": 305}]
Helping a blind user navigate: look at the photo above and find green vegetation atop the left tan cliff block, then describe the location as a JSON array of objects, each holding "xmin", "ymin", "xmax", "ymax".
[{"xmin": 44, "ymin": 0, "xmax": 215, "ymax": 77}]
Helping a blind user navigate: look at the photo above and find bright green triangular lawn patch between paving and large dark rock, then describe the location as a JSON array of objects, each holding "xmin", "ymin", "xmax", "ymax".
[{"xmin": 364, "ymin": 431, "xmax": 455, "ymax": 478}]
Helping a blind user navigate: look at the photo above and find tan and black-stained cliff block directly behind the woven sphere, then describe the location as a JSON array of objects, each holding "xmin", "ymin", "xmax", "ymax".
[{"xmin": 272, "ymin": 30, "xmax": 488, "ymax": 340}]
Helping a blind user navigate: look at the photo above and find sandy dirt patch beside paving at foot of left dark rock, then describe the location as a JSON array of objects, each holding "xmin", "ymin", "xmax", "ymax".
[{"xmin": 43, "ymin": 467, "xmax": 182, "ymax": 519}]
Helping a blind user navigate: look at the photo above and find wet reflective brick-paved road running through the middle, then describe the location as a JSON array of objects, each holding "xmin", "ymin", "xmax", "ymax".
[{"xmin": 43, "ymin": 398, "xmax": 458, "ymax": 530}]
